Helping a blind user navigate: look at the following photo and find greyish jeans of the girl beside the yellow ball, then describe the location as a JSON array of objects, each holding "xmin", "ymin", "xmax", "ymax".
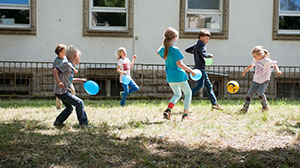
[{"xmin": 243, "ymin": 81, "xmax": 270, "ymax": 110}]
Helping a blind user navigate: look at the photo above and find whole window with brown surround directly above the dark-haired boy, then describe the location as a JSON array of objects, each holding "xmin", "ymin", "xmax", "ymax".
[{"xmin": 180, "ymin": 0, "xmax": 229, "ymax": 39}]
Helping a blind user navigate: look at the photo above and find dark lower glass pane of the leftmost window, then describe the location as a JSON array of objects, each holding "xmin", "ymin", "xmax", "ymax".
[{"xmin": 0, "ymin": 9, "xmax": 30, "ymax": 24}]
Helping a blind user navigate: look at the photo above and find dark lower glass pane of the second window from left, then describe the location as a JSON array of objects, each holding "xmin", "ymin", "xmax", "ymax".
[{"xmin": 93, "ymin": 12, "xmax": 126, "ymax": 27}]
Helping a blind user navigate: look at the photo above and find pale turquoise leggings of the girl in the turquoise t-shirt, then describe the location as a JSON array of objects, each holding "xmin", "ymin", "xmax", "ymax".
[{"xmin": 169, "ymin": 81, "xmax": 192, "ymax": 110}]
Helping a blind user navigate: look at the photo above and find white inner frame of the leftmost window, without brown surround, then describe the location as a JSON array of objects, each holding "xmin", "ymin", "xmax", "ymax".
[{"xmin": 0, "ymin": 0, "xmax": 32, "ymax": 28}]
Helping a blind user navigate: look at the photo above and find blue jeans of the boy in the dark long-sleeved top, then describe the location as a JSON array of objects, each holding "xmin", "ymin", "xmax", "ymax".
[{"xmin": 192, "ymin": 70, "xmax": 218, "ymax": 105}]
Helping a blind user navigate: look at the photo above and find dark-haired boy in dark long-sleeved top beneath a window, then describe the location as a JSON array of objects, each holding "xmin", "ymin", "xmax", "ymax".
[{"xmin": 185, "ymin": 29, "xmax": 223, "ymax": 110}]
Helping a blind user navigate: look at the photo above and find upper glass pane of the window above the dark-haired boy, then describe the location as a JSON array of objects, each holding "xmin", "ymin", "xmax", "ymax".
[{"xmin": 188, "ymin": 0, "xmax": 220, "ymax": 9}]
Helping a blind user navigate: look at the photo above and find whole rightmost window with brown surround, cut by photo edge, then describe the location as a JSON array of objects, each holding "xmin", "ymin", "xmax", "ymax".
[{"xmin": 273, "ymin": 0, "xmax": 300, "ymax": 40}]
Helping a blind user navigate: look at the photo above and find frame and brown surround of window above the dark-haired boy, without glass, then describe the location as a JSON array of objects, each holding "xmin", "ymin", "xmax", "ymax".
[{"xmin": 179, "ymin": 0, "xmax": 229, "ymax": 39}]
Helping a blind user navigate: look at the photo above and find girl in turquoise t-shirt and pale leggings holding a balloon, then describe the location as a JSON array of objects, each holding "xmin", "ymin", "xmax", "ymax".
[{"xmin": 157, "ymin": 27, "xmax": 196, "ymax": 120}]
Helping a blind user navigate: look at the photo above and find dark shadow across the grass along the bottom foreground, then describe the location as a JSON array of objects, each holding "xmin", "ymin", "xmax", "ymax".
[{"xmin": 0, "ymin": 120, "xmax": 300, "ymax": 168}]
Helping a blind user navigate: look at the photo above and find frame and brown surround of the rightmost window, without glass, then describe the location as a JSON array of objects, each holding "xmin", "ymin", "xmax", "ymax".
[{"xmin": 272, "ymin": 0, "xmax": 300, "ymax": 40}]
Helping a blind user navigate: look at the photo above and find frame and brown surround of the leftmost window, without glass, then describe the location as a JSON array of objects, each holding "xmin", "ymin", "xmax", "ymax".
[{"xmin": 0, "ymin": 0, "xmax": 37, "ymax": 35}]
